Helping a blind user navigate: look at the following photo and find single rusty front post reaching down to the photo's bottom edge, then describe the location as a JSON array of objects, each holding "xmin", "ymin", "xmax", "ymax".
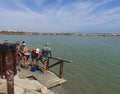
[{"xmin": 3, "ymin": 46, "xmax": 14, "ymax": 94}]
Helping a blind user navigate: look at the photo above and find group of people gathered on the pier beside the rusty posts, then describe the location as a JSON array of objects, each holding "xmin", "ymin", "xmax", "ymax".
[{"xmin": 16, "ymin": 41, "xmax": 52, "ymax": 72}]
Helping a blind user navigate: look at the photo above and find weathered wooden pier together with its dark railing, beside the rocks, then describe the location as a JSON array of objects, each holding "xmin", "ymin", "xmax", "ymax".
[{"xmin": 17, "ymin": 57, "xmax": 72, "ymax": 88}]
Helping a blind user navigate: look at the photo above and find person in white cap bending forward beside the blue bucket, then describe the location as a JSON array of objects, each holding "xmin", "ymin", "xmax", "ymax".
[{"xmin": 31, "ymin": 48, "xmax": 41, "ymax": 69}]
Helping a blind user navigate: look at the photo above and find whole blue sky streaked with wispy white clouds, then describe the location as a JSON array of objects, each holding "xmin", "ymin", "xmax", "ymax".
[{"xmin": 0, "ymin": 0, "xmax": 120, "ymax": 33}]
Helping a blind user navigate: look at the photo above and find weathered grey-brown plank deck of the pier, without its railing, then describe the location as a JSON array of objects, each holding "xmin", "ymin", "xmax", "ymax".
[{"xmin": 17, "ymin": 69, "xmax": 66, "ymax": 88}]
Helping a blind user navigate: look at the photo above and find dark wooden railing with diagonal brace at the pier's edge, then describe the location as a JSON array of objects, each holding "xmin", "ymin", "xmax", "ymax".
[{"xmin": 47, "ymin": 57, "xmax": 72, "ymax": 78}]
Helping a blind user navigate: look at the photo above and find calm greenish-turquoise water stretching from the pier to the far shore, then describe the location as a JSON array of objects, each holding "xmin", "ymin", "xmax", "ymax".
[{"xmin": 0, "ymin": 35, "xmax": 120, "ymax": 94}]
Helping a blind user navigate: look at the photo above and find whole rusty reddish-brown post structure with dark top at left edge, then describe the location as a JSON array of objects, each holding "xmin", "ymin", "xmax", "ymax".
[{"xmin": 0, "ymin": 43, "xmax": 17, "ymax": 94}]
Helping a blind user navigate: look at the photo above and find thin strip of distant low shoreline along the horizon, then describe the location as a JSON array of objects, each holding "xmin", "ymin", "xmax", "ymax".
[{"xmin": 0, "ymin": 31, "xmax": 120, "ymax": 36}]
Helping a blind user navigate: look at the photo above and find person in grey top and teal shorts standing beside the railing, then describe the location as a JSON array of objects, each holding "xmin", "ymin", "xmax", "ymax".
[{"xmin": 41, "ymin": 43, "xmax": 52, "ymax": 73}]
